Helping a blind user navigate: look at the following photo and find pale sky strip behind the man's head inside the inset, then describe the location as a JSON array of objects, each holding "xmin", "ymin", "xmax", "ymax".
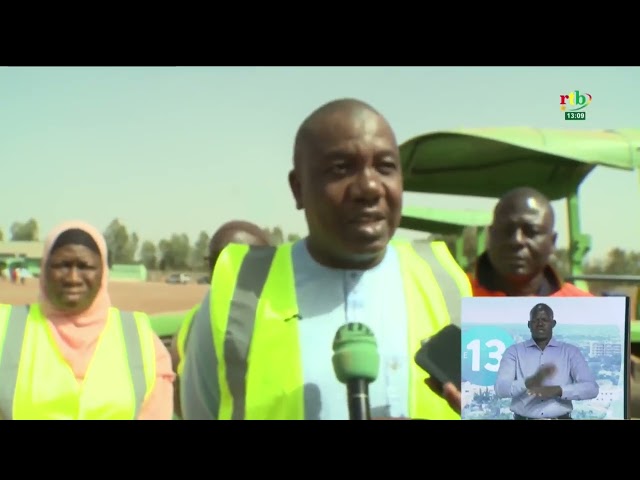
[{"xmin": 462, "ymin": 297, "xmax": 627, "ymax": 330}]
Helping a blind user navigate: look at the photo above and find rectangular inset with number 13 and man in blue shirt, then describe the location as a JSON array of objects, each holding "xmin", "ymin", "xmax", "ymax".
[{"xmin": 461, "ymin": 297, "xmax": 629, "ymax": 420}]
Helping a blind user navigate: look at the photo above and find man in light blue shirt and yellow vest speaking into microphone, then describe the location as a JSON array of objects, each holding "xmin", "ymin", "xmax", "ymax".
[{"xmin": 180, "ymin": 99, "xmax": 471, "ymax": 420}]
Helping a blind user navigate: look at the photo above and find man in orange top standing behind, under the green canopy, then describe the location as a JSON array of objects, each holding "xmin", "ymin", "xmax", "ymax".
[{"xmin": 470, "ymin": 187, "xmax": 593, "ymax": 297}]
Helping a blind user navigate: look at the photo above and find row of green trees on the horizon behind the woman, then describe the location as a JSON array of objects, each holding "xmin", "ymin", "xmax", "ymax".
[{"xmin": 0, "ymin": 218, "xmax": 300, "ymax": 271}]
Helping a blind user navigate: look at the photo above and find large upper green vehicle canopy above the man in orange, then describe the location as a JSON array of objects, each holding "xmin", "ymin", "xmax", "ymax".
[{"xmin": 400, "ymin": 127, "xmax": 640, "ymax": 200}]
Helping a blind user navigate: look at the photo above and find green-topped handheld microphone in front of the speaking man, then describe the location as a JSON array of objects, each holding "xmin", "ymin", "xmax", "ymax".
[{"xmin": 331, "ymin": 323, "xmax": 380, "ymax": 420}]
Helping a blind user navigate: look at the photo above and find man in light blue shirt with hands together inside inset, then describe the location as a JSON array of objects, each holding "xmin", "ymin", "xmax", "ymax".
[{"xmin": 495, "ymin": 303, "xmax": 600, "ymax": 420}]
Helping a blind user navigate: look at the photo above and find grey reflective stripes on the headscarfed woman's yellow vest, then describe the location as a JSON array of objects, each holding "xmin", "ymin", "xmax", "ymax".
[{"xmin": 0, "ymin": 305, "xmax": 148, "ymax": 420}]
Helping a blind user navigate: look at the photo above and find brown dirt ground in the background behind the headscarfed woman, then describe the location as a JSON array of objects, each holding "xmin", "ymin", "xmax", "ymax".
[{"xmin": 0, "ymin": 279, "xmax": 208, "ymax": 314}]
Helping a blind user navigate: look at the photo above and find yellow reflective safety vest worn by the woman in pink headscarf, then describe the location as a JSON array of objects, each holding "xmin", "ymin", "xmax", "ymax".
[{"xmin": 0, "ymin": 304, "xmax": 156, "ymax": 420}]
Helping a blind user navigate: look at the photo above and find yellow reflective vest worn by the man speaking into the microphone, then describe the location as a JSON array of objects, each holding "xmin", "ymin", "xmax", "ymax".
[{"xmin": 210, "ymin": 241, "xmax": 472, "ymax": 420}]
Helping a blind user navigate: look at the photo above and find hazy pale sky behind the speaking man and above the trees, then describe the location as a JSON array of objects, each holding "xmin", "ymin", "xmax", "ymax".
[{"xmin": 0, "ymin": 67, "xmax": 640, "ymax": 257}]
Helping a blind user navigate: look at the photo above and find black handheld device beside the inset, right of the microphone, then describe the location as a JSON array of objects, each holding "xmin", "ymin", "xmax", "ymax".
[{"xmin": 414, "ymin": 325, "xmax": 462, "ymax": 390}]
